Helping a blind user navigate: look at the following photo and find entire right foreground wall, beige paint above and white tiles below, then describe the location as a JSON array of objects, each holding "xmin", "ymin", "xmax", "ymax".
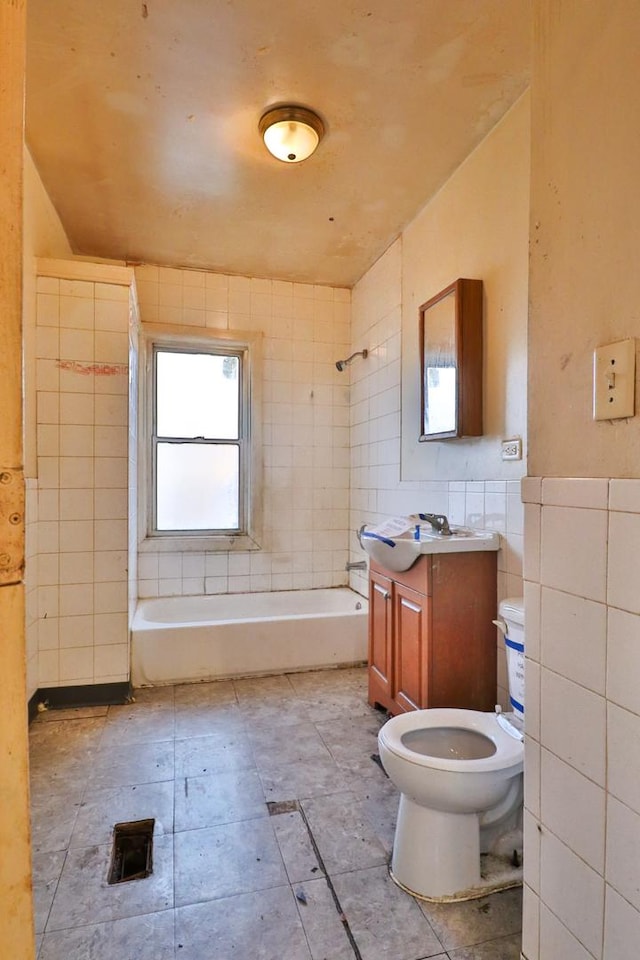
[{"xmin": 523, "ymin": 0, "xmax": 640, "ymax": 960}]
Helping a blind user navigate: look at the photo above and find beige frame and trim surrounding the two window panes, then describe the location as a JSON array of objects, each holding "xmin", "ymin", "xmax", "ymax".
[{"xmin": 138, "ymin": 324, "xmax": 262, "ymax": 553}]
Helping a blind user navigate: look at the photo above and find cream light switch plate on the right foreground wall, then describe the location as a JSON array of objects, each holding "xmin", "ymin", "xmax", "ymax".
[{"xmin": 593, "ymin": 340, "xmax": 636, "ymax": 420}]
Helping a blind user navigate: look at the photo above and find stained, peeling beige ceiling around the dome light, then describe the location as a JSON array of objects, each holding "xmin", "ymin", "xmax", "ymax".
[{"xmin": 26, "ymin": 0, "xmax": 530, "ymax": 286}]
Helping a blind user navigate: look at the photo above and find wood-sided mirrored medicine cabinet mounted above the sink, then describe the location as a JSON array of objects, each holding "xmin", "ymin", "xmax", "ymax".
[{"xmin": 419, "ymin": 279, "xmax": 482, "ymax": 440}]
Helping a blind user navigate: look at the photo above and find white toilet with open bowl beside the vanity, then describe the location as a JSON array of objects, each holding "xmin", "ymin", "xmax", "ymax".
[{"xmin": 378, "ymin": 598, "xmax": 524, "ymax": 900}]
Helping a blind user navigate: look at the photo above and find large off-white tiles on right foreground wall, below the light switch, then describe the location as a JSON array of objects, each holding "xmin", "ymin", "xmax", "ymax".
[{"xmin": 523, "ymin": 478, "xmax": 640, "ymax": 960}]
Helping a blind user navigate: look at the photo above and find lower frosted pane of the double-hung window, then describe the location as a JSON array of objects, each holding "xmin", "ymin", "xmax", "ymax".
[{"xmin": 156, "ymin": 443, "xmax": 240, "ymax": 530}]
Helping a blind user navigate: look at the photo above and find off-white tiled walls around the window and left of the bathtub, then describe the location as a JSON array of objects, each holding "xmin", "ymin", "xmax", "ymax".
[{"xmin": 27, "ymin": 261, "xmax": 350, "ymax": 694}]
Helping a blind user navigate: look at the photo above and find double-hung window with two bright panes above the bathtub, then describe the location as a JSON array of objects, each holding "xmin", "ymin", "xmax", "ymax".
[{"xmin": 143, "ymin": 331, "xmax": 257, "ymax": 550}]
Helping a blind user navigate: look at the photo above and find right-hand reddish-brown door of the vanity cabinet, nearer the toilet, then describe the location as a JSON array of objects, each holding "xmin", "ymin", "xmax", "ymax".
[{"xmin": 393, "ymin": 583, "xmax": 429, "ymax": 711}]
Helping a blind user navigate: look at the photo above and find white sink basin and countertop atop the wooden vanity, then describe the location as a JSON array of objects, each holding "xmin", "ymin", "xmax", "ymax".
[{"xmin": 361, "ymin": 527, "xmax": 500, "ymax": 573}]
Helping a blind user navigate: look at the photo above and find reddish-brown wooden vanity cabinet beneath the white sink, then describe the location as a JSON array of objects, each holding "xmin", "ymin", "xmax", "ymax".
[{"xmin": 369, "ymin": 551, "xmax": 497, "ymax": 714}]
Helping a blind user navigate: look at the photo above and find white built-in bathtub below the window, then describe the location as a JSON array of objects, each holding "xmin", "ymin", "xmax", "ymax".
[{"xmin": 131, "ymin": 587, "xmax": 368, "ymax": 687}]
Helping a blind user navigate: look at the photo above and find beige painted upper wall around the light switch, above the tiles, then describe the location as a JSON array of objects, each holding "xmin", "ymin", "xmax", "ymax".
[{"xmin": 529, "ymin": 0, "xmax": 640, "ymax": 477}]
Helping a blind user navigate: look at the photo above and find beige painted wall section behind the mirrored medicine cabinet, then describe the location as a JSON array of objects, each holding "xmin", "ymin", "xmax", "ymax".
[{"xmin": 402, "ymin": 93, "xmax": 530, "ymax": 480}]
